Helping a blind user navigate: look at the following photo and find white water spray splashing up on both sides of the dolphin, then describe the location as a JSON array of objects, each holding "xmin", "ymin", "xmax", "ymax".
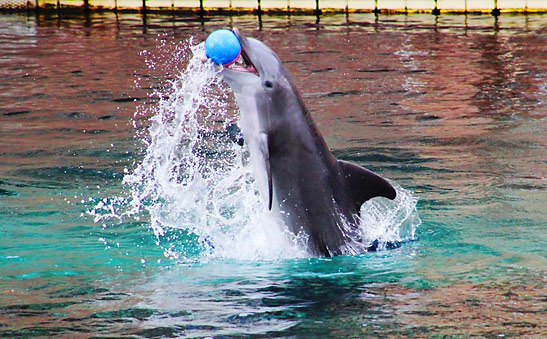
[{"xmin": 90, "ymin": 36, "xmax": 419, "ymax": 260}]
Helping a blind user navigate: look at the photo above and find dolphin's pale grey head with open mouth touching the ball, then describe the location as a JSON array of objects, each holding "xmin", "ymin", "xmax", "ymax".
[{"xmin": 221, "ymin": 28, "xmax": 294, "ymax": 96}]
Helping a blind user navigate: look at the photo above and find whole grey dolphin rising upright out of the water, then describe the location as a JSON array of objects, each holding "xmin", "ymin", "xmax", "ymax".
[{"xmin": 220, "ymin": 29, "xmax": 396, "ymax": 257}]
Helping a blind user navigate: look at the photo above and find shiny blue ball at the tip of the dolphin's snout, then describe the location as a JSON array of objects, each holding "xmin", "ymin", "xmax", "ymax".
[{"xmin": 205, "ymin": 29, "xmax": 241, "ymax": 66}]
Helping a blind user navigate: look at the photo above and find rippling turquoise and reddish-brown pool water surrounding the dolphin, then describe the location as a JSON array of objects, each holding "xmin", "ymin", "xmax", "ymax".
[{"xmin": 0, "ymin": 14, "xmax": 547, "ymax": 337}]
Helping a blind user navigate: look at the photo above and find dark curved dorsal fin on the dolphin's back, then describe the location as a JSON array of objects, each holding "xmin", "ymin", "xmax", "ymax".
[{"xmin": 337, "ymin": 160, "xmax": 397, "ymax": 210}]
